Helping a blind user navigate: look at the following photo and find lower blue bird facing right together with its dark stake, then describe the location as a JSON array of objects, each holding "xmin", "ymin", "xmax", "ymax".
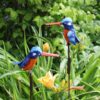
[{"xmin": 14, "ymin": 46, "xmax": 59, "ymax": 100}]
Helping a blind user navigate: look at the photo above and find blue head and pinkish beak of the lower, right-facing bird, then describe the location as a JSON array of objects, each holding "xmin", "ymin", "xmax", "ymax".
[{"xmin": 30, "ymin": 46, "xmax": 59, "ymax": 58}]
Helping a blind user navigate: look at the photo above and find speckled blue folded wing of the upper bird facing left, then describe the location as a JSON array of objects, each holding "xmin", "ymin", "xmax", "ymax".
[{"xmin": 67, "ymin": 30, "xmax": 79, "ymax": 45}]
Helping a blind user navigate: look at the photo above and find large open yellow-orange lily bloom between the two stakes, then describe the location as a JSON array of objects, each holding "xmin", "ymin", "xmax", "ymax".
[{"xmin": 38, "ymin": 71, "xmax": 57, "ymax": 89}]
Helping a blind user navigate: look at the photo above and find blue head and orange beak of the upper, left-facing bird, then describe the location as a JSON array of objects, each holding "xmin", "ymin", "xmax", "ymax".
[{"xmin": 46, "ymin": 17, "xmax": 73, "ymax": 30}]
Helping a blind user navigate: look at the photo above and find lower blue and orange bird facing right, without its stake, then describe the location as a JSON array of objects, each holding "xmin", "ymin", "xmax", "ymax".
[{"xmin": 14, "ymin": 46, "xmax": 59, "ymax": 70}]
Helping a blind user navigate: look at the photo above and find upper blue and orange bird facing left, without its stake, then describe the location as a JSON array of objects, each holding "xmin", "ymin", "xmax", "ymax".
[{"xmin": 46, "ymin": 17, "xmax": 79, "ymax": 45}]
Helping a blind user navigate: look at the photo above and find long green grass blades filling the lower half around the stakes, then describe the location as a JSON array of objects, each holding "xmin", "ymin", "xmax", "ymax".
[{"xmin": 0, "ymin": 26, "xmax": 100, "ymax": 100}]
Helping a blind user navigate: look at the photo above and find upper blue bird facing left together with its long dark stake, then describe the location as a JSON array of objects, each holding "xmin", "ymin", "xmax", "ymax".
[{"xmin": 46, "ymin": 17, "xmax": 79, "ymax": 98}]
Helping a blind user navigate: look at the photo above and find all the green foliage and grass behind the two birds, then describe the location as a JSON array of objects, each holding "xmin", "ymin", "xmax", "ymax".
[{"xmin": 0, "ymin": 0, "xmax": 100, "ymax": 100}]
